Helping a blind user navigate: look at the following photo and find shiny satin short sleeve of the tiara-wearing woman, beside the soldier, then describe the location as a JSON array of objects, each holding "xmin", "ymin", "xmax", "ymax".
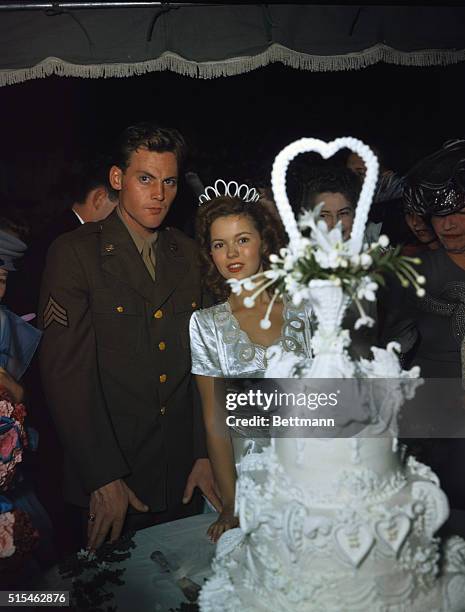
[{"xmin": 189, "ymin": 310, "xmax": 224, "ymax": 377}]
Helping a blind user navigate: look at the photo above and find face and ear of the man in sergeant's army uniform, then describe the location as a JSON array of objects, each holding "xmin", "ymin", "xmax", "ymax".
[{"xmin": 110, "ymin": 148, "xmax": 178, "ymax": 236}]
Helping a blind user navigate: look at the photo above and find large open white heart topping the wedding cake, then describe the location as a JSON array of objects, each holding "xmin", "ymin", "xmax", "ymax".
[{"xmin": 271, "ymin": 137, "xmax": 379, "ymax": 254}]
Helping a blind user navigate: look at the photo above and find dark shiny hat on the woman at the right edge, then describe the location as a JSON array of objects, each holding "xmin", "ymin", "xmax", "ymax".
[{"xmin": 404, "ymin": 138, "xmax": 465, "ymax": 216}]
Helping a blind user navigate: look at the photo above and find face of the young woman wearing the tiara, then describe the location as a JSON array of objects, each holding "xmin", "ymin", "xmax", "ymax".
[{"xmin": 210, "ymin": 215, "xmax": 262, "ymax": 279}]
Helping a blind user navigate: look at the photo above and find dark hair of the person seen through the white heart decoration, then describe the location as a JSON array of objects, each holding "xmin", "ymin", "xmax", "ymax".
[{"xmin": 302, "ymin": 167, "xmax": 360, "ymax": 209}]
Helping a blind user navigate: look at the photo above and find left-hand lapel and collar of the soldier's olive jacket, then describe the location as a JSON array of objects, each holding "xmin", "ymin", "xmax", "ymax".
[{"xmin": 100, "ymin": 211, "xmax": 158, "ymax": 303}]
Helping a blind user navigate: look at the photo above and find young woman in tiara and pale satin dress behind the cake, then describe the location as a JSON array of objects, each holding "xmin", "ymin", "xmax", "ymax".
[{"xmin": 190, "ymin": 181, "xmax": 310, "ymax": 542}]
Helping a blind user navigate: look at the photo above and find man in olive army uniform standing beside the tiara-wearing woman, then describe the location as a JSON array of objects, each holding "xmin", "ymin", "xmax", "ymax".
[{"xmin": 39, "ymin": 124, "xmax": 219, "ymax": 549}]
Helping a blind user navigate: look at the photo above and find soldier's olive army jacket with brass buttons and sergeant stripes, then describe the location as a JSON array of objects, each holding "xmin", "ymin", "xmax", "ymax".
[{"xmin": 39, "ymin": 211, "xmax": 206, "ymax": 512}]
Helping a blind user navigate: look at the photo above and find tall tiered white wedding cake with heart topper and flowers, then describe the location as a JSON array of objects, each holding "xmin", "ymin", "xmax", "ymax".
[{"xmin": 199, "ymin": 138, "xmax": 465, "ymax": 612}]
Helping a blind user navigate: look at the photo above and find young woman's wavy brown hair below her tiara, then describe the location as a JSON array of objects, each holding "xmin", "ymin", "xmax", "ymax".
[{"xmin": 195, "ymin": 196, "xmax": 286, "ymax": 302}]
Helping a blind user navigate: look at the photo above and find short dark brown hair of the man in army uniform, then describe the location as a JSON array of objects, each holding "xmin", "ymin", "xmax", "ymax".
[{"xmin": 113, "ymin": 122, "xmax": 187, "ymax": 171}]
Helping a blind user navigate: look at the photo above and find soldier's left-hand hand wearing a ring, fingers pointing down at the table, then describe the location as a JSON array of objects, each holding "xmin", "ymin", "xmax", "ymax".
[{"xmin": 87, "ymin": 479, "xmax": 148, "ymax": 550}]
